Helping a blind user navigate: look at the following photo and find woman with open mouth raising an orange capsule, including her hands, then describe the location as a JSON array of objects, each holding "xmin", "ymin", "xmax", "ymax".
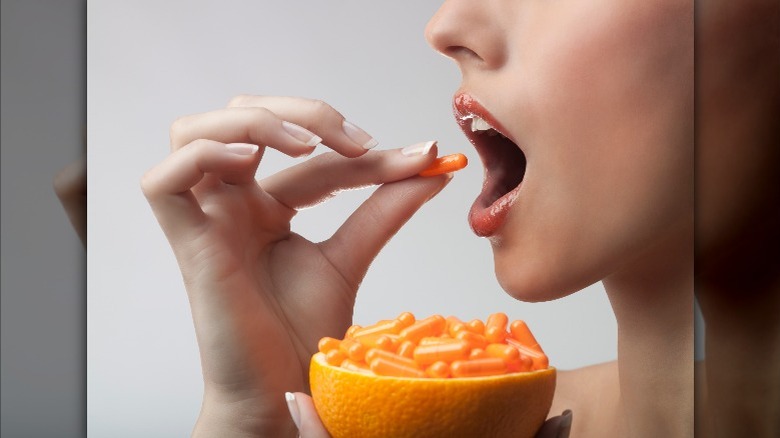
[{"xmin": 142, "ymin": 0, "xmax": 693, "ymax": 438}]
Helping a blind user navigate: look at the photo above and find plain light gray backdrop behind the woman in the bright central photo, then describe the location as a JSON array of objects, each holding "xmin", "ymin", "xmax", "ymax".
[{"xmin": 87, "ymin": 0, "xmax": 616, "ymax": 438}]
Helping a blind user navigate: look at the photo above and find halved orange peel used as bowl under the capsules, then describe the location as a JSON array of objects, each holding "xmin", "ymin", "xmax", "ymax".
[{"xmin": 309, "ymin": 314, "xmax": 556, "ymax": 438}]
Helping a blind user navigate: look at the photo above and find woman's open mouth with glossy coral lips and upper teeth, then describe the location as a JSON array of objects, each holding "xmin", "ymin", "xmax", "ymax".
[{"xmin": 453, "ymin": 94, "xmax": 527, "ymax": 237}]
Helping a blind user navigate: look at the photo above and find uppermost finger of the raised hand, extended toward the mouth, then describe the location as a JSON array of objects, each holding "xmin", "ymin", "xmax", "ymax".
[{"xmin": 228, "ymin": 95, "xmax": 377, "ymax": 157}]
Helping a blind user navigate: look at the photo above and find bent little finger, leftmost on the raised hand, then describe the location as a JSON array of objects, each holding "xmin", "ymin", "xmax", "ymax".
[{"xmin": 141, "ymin": 140, "xmax": 261, "ymax": 237}]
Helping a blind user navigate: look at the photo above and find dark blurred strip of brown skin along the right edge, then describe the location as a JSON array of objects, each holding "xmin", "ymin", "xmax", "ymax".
[{"xmin": 696, "ymin": 0, "xmax": 780, "ymax": 437}]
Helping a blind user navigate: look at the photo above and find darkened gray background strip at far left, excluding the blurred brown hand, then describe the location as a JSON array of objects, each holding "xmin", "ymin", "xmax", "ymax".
[{"xmin": 0, "ymin": 0, "xmax": 86, "ymax": 438}]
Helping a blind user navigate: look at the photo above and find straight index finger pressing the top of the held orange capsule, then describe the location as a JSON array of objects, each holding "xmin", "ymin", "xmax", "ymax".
[{"xmin": 260, "ymin": 141, "xmax": 437, "ymax": 209}]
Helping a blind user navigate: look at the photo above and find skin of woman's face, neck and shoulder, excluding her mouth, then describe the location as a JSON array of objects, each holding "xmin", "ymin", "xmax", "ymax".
[{"xmin": 426, "ymin": 0, "xmax": 693, "ymax": 437}]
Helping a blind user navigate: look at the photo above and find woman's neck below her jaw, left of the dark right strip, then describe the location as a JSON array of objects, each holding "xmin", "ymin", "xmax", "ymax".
[{"xmin": 604, "ymin": 227, "xmax": 694, "ymax": 437}]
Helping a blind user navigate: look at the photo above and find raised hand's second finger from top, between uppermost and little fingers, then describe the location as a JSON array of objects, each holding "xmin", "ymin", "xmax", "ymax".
[{"xmin": 171, "ymin": 108, "xmax": 322, "ymax": 157}]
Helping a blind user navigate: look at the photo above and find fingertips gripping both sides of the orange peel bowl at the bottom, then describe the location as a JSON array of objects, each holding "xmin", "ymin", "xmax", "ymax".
[{"xmin": 285, "ymin": 393, "xmax": 572, "ymax": 438}]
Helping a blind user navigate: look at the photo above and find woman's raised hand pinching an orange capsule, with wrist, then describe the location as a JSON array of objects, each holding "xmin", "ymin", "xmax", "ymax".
[{"xmin": 141, "ymin": 96, "xmax": 449, "ymax": 437}]
